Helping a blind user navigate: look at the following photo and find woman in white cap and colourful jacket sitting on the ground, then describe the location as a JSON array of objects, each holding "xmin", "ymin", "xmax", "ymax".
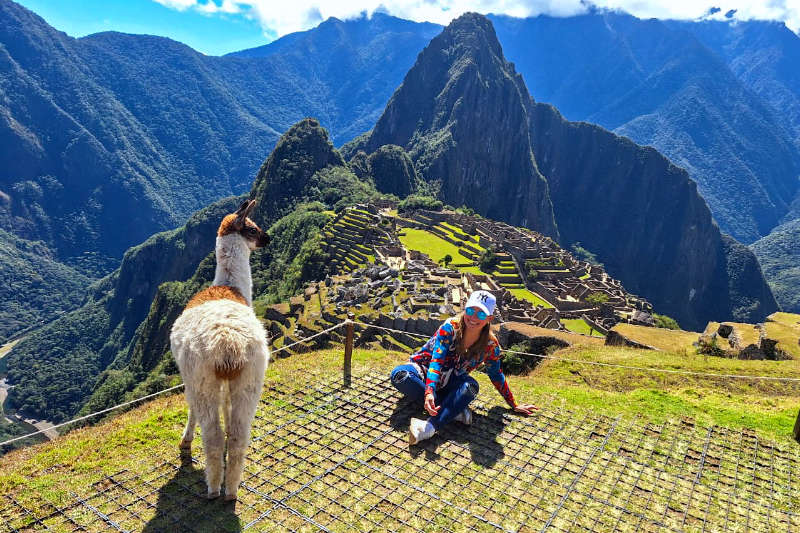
[{"xmin": 392, "ymin": 291, "xmax": 537, "ymax": 444}]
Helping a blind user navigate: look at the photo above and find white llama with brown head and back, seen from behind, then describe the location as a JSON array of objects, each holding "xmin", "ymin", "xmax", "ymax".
[{"xmin": 170, "ymin": 200, "xmax": 269, "ymax": 501}]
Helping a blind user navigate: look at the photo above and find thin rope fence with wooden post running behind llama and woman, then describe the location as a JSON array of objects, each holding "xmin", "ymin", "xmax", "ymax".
[{"xmin": 0, "ymin": 314, "xmax": 800, "ymax": 447}]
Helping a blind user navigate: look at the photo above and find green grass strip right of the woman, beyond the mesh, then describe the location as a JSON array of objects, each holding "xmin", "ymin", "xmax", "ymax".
[{"xmin": 510, "ymin": 346, "xmax": 800, "ymax": 442}]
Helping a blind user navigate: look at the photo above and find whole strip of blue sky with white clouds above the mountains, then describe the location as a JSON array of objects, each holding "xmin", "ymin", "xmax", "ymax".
[{"xmin": 17, "ymin": 0, "xmax": 800, "ymax": 55}]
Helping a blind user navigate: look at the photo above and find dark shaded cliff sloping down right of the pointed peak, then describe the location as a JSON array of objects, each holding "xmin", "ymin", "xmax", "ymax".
[{"xmin": 531, "ymin": 104, "xmax": 777, "ymax": 330}]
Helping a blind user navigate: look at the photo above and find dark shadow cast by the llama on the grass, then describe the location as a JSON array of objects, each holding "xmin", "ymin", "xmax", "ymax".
[{"xmin": 142, "ymin": 453, "xmax": 242, "ymax": 533}]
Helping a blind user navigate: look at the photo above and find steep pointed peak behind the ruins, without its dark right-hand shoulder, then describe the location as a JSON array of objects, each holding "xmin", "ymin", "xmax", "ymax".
[{"xmin": 349, "ymin": 15, "xmax": 558, "ymax": 237}]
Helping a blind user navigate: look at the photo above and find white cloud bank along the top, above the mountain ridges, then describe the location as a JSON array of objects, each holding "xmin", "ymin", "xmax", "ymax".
[{"xmin": 148, "ymin": 0, "xmax": 800, "ymax": 36}]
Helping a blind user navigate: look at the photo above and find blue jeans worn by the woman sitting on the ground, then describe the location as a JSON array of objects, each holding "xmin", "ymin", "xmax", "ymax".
[{"xmin": 392, "ymin": 364, "xmax": 479, "ymax": 431}]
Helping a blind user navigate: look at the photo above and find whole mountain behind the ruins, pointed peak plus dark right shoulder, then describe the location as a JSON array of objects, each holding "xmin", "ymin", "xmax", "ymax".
[{"xmin": 345, "ymin": 14, "xmax": 777, "ymax": 328}]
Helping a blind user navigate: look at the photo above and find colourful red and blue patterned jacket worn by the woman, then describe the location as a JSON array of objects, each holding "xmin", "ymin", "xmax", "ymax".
[{"xmin": 411, "ymin": 317, "xmax": 517, "ymax": 409}]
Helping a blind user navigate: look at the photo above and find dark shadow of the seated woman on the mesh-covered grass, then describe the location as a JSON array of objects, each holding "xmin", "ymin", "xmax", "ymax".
[{"xmin": 389, "ymin": 398, "xmax": 508, "ymax": 468}]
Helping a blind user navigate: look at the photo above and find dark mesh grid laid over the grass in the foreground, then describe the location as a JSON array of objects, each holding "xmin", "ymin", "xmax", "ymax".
[{"xmin": 0, "ymin": 373, "xmax": 800, "ymax": 532}]
